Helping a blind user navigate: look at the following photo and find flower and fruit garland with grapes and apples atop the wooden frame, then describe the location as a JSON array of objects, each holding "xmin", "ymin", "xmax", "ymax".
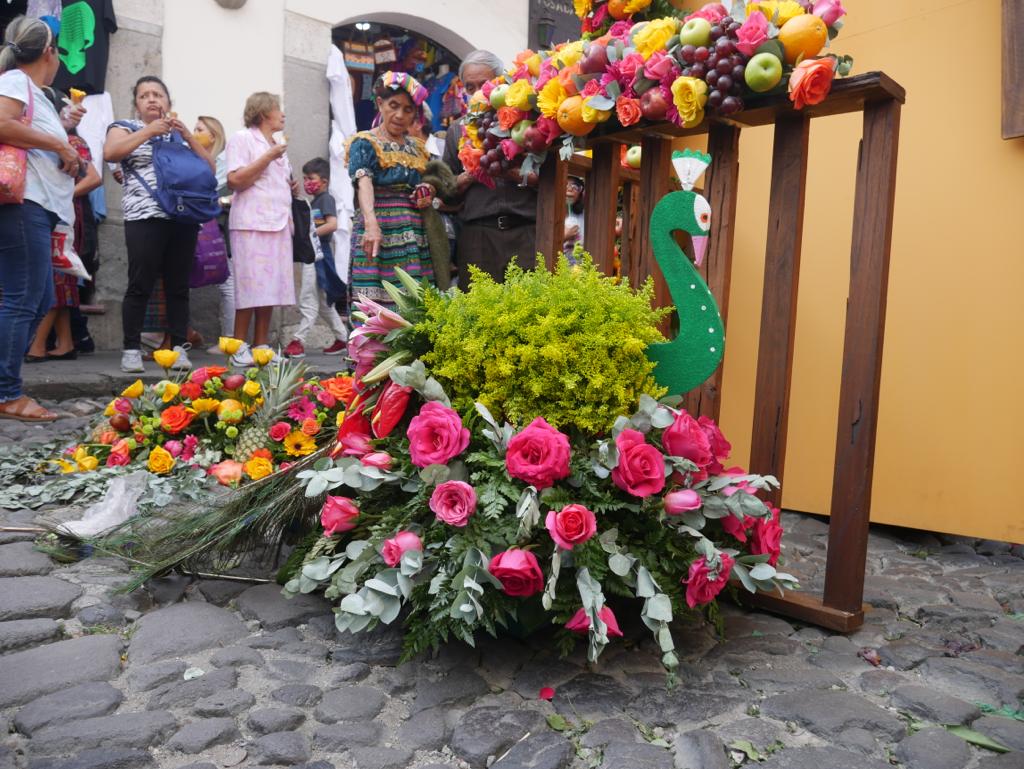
[{"xmin": 459, "ymin": 0, "xmax": 853, "ymax": 185}]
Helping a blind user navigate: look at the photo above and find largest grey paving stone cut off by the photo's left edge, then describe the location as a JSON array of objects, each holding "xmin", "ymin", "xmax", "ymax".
[{"xmin": 0, "ymin": 634, "xmax": 121, "ymax": 709}]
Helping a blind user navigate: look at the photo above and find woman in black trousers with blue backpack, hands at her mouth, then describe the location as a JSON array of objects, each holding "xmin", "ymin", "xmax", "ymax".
[{"xmin": 103, "ymin": 75, "xmax": 220, "ymax": 374}]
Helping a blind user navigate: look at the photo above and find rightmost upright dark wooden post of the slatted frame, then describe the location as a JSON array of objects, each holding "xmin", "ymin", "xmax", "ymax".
[{"xmin": 824, "ymin": 99, "xmax": 900, "ymax": 611}]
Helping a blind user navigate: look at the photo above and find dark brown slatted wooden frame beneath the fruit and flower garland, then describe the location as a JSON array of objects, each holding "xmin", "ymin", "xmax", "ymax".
[{"xmin": 537, "ymin": 73, "xmax": 905, "ymax": 632}]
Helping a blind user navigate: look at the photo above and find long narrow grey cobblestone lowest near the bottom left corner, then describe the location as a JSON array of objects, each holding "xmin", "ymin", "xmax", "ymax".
[{"xmin": 32, "ymin": 711, "xmax": 178, "ymax": 755}]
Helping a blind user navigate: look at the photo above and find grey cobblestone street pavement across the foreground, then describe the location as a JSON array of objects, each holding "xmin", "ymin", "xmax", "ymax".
[{"xmin": 0, "ymin": 407, "xmax": 1024, "ymax": 769}]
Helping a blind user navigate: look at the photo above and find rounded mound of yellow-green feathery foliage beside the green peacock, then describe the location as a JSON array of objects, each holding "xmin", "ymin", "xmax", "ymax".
[{"xmin": 417, "ymin": 254, "xmax": 668, "ymax": 432}]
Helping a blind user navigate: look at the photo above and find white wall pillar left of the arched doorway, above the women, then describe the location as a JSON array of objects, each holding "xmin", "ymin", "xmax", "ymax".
[{"xmin": 163, "ymin": 0, "xmax": 287, "ymax": 136}]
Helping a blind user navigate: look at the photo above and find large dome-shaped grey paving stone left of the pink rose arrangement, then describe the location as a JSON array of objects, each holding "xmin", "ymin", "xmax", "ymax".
[{"xmin": 128, "ymin": 601, "xmax": 248, "ymax": 663}]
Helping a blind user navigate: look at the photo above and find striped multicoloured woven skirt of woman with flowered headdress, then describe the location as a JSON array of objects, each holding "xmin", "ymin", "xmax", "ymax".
[{"xmin": 348, "ymin": 187, "xmax": 434, "ymax": 306}]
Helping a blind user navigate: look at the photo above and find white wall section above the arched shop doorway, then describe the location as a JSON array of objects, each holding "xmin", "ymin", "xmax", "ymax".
[{"xmin": 286, "ymin": 0, "xmax": 528, "ymax": 68}]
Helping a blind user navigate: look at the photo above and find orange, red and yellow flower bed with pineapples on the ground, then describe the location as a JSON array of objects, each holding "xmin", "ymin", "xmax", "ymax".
[{"xmin": 50, "ymin": 337, "xmax": 355, "ymax": 485}]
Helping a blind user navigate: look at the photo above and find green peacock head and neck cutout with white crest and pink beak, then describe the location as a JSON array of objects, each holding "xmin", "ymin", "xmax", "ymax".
[{"xmin": 647, "ymin": 149, "xmax": 725, "ymax": 395}]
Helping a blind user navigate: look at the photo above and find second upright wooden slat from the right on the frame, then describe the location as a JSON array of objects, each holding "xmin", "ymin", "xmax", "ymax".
[{"xmin": 751, "ymin": 116, "xmax": 810, "ymax": 507}]
